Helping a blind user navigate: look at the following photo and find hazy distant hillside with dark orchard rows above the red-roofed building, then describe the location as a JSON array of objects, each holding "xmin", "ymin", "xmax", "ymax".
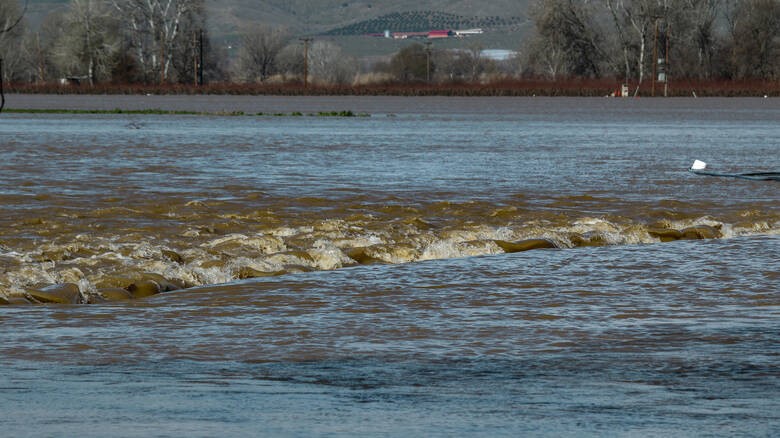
[{"xmin": 26, "ymin": 0, "xmax": 529, "ymax": 41}]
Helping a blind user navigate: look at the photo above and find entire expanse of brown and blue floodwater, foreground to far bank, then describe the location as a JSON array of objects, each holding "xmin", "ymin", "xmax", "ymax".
[{"xmin": 0, "ymin": 96, "xmax": 780, "ymax": 436}]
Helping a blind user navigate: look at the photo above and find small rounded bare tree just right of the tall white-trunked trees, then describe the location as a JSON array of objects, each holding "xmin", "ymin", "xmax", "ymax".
[{"xmin": 235, "ymin": 25, "xmax": 290, "ymax": 82}]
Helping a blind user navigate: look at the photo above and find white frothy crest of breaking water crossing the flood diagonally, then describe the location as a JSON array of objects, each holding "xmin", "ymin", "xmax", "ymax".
[{"xmin": 0, "ymin": 210, "xmax": 780, "ymax": 302}]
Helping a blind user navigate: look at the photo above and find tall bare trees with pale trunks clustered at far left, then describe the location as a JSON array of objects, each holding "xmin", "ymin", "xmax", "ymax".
[{"xmin": 0, "ymin": 0, "xmax": 219, "ymax": 83}]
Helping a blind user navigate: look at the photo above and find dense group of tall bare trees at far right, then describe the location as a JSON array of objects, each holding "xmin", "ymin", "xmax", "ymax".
[{"xmin": 526, "ymin": 0, "xmax": 780, "ymax": 83}]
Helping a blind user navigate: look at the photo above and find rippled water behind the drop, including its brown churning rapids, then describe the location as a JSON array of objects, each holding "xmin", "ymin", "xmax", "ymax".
[{"xmin": 0, "ymin": 100, "xmax": 780, "ymax": 304}]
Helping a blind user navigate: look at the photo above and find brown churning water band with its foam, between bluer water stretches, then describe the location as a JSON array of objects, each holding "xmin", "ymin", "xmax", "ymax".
[{"xmin": 0, "ymin": 193, "xmax": 780, "ymax": 305}]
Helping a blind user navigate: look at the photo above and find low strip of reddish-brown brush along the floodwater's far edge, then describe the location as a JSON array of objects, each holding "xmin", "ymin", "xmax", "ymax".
[{"xmin": 6, "ymin": 79, "xmax": 780, "ymax": 97}]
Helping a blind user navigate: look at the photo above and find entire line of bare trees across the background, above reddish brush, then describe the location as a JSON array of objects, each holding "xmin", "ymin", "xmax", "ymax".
[{"xmin": 0, "ymin": 0, "xmax": 780, "ymax": 85}]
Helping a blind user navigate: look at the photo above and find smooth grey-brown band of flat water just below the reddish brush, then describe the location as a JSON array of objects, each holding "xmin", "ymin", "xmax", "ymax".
[{"xmin": 0, "ymin": 94, "xmax": 780, "ymax": 119}]
